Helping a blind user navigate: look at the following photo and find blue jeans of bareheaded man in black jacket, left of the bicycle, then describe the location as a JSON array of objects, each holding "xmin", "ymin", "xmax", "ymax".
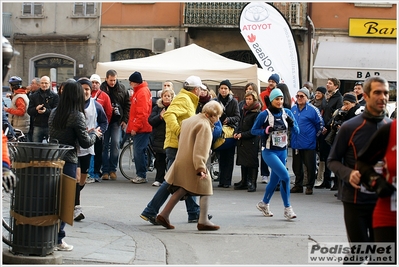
[{"xmin": 102, "ymin": 122, "xmax": 121, "ymax": 173}]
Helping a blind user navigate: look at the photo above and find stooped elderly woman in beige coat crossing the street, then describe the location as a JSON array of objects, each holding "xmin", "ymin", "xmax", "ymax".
[{"xmin": 156, "ymin": 101, "xmax": 223, "ymax": 230}]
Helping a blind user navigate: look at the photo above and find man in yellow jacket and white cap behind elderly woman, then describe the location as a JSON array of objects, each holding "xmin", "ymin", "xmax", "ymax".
[{"xmin": 140, "ymin": 76, "xmax": 206, "ymax": 224}]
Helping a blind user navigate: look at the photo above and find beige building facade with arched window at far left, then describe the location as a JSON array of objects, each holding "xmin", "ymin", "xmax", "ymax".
[{"xmin": 2, "ymin": 2, "xmax": 101, "ymax": 86}]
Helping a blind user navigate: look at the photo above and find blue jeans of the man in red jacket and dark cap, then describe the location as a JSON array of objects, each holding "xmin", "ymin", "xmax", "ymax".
[{"xmin": 133, "ymin": 133, "xmax": 150, "ymax": 178}]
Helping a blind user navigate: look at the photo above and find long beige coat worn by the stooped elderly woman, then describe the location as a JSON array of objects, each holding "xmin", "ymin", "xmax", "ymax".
[{"xmin": 165, "ymin": 113, "xmax": 214, "ymax": 196}]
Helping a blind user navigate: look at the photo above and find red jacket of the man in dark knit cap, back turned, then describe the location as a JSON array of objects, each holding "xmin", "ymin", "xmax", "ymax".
[{"xmin": 126, "ymin": 81, "xmax": 152, "ymax": 133}]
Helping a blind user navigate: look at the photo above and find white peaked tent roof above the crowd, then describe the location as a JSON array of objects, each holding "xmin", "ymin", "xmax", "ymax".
[{"xmin": 96, "ymin": 44, "xmax": 258, "ymax": 86}]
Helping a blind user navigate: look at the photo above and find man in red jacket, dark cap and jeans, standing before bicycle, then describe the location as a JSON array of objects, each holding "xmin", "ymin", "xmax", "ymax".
[{"xmin": 126, "ymin": 71, "xmax": 152, "ymax": 184}]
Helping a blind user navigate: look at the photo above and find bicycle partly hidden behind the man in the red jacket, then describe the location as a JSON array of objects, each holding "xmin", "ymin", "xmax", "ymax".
[{"xmin": 119, "ymin": 135, "xmax": 155, "ymax": 180}]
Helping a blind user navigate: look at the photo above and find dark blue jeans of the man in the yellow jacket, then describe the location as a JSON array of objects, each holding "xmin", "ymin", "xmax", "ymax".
[{"xmin": 141, "ymin": 148, "xmax": 200, "ymax": 220}]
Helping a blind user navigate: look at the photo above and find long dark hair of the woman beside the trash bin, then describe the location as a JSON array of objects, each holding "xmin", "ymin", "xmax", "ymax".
[{"xmin": 53, "ymin": 82, "xmax": 85, "ymax": 129}]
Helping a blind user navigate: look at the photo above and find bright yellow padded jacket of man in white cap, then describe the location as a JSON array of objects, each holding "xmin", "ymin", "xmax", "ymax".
[{"xmin": 163, "ymin": 89, "xmax": 199, "ymax": 149}]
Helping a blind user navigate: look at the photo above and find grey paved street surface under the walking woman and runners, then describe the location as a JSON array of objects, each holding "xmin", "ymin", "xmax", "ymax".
[{"xmin": 3, "ymin": 153, "xmax": 346, "ymax": 265}]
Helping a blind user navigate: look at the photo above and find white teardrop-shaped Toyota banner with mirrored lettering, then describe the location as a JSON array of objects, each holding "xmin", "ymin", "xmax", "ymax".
[{"xmin": 240, "ymin": 2, "xmax": 301, "ymax": 103}]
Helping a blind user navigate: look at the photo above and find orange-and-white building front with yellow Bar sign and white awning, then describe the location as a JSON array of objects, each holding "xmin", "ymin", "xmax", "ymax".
[{"xmin": 308, "ymin": 2, "xmax": 398, "ymax": 97}]
